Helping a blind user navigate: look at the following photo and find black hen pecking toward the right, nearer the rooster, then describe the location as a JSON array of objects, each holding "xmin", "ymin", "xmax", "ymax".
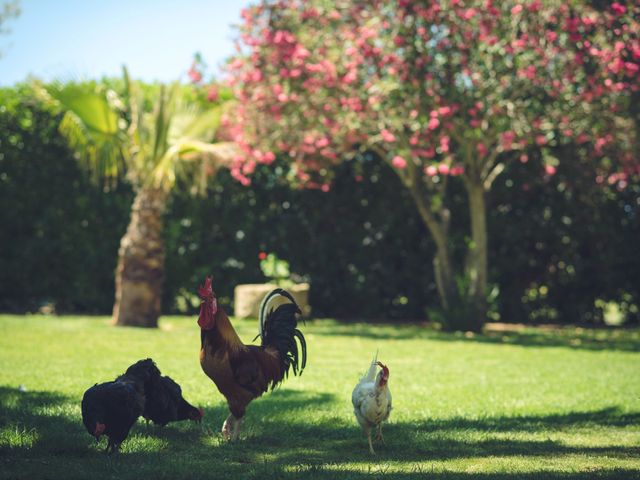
[{"xmin": 125, "ymin": 358, "xmax": 204, "ymax": 426}]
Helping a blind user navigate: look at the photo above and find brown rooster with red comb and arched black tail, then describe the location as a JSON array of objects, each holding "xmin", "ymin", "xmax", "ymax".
[{"xmin": 198, "ymin": 277, "xmax": 307, "ymax": 440}]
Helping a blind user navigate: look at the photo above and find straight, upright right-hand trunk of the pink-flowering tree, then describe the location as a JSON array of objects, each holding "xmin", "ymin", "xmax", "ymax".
[{"xmin": 466, "ymin": 182, "xmax": 488, "ymax": 332}]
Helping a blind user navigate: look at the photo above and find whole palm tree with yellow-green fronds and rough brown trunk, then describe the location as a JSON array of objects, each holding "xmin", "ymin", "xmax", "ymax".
[{"xmin": 43, "ymin": 69, "xmax": 239, "ymax": 327}]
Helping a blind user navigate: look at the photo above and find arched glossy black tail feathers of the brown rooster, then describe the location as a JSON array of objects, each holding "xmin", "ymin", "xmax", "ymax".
[{"xmin": 260, "ymin": 288, "xmax": 307, "ymax": 377}]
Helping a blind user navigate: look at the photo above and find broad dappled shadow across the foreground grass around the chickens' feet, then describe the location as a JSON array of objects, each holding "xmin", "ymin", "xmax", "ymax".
[{"xmin": 0, "ymin": 387, "xmax": 640, "ymax": 480}]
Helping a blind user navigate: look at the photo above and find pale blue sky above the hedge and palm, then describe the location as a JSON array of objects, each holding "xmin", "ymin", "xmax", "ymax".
[{"xmin": 0, "ymin": 0, "xmax": 255, "ymax": 86}]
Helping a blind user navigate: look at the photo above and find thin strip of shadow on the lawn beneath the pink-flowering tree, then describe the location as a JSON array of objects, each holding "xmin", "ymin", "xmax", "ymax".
[{"xmin": 314, "ymin": 323, "xmax": 640, "ymax": 352}]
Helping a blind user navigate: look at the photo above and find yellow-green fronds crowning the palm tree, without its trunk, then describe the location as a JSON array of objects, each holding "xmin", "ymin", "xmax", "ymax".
[{"xmin": 37, "ymin": 68, "xmax": 237, "ymax": 192}]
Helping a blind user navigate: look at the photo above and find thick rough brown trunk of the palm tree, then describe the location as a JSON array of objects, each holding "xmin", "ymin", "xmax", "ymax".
[{"xmin": 113, "ymin": 187, "xmax": 166, "ymax": 328}]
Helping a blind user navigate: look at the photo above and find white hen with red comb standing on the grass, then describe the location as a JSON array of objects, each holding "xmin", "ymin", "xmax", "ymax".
[{"xmin": 351, "ymin": 354, "xmax": 391, "ymax": 454}]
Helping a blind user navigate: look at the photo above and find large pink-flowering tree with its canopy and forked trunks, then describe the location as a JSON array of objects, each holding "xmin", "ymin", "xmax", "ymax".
[{"xmin": 229, "ymin": 0, "xmax": 640, "ymax": 330}]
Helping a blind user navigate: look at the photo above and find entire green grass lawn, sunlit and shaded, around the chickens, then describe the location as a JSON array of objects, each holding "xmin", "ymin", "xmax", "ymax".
[{"xmin": 0, "ymin": 315, "xmax": 640, "ymax": 479}]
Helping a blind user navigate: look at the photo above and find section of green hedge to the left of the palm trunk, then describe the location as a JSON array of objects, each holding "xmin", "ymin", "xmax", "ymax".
[{"xmin": 0, "ymin": 87, "xmax": 132, "ymax": 313}]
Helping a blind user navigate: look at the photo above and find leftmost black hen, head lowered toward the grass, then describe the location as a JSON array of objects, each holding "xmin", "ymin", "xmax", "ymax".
[{"xmin": 82, "ymin": 377, "xmax": 145, "ymax": 453}]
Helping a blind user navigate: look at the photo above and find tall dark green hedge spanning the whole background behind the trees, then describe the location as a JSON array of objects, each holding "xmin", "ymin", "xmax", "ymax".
[{"xmin": 0, "ymin": 87, "xmax": 640, "ymax": 322}]
